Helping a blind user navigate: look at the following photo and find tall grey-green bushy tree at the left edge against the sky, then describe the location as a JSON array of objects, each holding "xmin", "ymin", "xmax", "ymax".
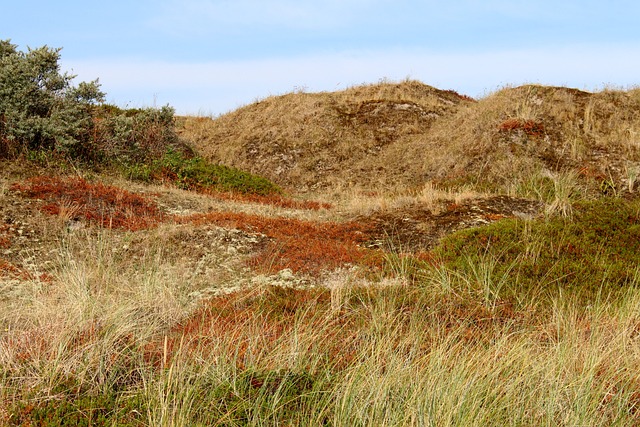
[{"xmin": 0, "ymin": 40, "xmax": 105, "ymax": 157}]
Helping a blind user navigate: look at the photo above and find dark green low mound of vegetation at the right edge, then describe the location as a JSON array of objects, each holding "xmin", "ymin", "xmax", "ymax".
[{"xmin": 436, "ymin": 198, "xmax": 640, "ymax": 300}]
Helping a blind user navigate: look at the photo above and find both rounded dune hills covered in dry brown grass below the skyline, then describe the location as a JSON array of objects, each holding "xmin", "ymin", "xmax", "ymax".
[{"xmin": 180, "ymin": 81, "xmax": 640, "ymax": 193}]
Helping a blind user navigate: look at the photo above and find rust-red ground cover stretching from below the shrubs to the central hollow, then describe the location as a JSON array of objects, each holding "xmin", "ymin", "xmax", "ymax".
[{"xmin": 7, "ymin": 177, "xmax": 356, "ymax": 275}]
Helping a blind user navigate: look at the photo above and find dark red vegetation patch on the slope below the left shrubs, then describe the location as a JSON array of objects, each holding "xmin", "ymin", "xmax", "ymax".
[{"xmin": 12, "ymin": 177, "xmax": 164, "ymax": 231}]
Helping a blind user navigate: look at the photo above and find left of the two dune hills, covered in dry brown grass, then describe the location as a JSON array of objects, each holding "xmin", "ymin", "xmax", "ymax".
[{"xmin": 181, "ymin": 81, "xmax": 472, "ymax": 190}]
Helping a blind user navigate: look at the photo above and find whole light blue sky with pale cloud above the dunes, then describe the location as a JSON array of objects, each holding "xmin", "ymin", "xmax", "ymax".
[{"xmin": 0, "ymin": 0, "xmax": 640, "ymax": 115}]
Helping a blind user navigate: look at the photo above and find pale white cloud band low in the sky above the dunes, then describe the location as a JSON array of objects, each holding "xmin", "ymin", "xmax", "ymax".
[{"xmin": 63, "ymin": 46, "xmax": 640, "ymax": 114}]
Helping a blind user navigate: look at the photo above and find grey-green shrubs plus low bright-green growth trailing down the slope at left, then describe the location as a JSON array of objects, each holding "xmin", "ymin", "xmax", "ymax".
[{"xmin": 0, "ymin": 40, "xmax": 281, "ymax": 196}]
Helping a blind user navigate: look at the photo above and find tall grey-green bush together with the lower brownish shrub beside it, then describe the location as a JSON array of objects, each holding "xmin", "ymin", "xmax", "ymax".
[{"xmin": 0, "ymin": 40, "xmax": 189, "ymax": 164}]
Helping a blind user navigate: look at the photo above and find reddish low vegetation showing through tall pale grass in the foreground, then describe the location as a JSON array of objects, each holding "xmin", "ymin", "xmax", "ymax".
[{"xmin": 145, "ymin": 286, "xmax": 531, "ymax": 370}]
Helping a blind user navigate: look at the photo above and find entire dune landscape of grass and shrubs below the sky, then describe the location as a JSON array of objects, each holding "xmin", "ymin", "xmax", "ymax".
[{"xmin": 0, "ymin": 41, "xmax": 640, "ymax": 426}]
